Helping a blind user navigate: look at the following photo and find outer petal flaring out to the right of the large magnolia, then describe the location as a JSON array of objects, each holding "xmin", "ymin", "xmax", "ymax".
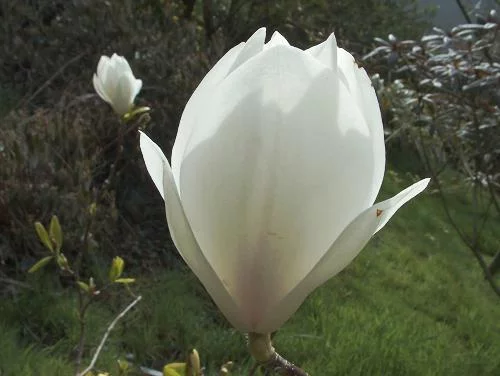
[{"xmin": 257, "ymin": 179, "xmax": 430, "ymax": 333}]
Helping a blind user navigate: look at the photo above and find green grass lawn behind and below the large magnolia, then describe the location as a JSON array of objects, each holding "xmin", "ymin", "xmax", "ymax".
[{"xmin": 0, "ymin": 173, "xmax": 500, "ymax": 376}]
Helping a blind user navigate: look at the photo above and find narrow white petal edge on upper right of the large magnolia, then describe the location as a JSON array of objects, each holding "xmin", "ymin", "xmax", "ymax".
[{"xmin": 337, "ymin": 48, "xmax": 385, "ymax": 203}]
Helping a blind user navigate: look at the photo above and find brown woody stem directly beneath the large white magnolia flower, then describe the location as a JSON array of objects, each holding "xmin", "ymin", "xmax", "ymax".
[{"xmin": 248, "ymin": 333, "xmax": 308, "ymax": 376}]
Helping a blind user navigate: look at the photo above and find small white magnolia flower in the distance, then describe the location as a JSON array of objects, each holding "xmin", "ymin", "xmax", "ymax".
[{"xmin": 93, "ymin": 54, "xmax": 142, "ymax": 116}]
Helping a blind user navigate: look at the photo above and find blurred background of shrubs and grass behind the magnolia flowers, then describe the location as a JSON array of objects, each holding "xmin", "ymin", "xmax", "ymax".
[{"xmin": 0, "ymin": 0, "xmax": 500, "ymax": 375}]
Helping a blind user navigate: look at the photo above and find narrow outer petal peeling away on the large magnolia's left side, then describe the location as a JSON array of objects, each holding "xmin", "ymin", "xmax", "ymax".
[{"xmin": 140, "ymin": 132, "xmax": 249, "ymax": 331}]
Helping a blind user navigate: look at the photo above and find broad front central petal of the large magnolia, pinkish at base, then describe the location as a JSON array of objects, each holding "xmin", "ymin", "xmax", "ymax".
[{"xmin": 180, "ymin": 45, "xmax": 374, "ymax": 327}]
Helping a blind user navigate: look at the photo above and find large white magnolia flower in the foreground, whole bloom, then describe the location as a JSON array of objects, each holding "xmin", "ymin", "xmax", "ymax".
[{"xmin": 140, "ymin": 29, "xmax": 429, "ymax": 333}]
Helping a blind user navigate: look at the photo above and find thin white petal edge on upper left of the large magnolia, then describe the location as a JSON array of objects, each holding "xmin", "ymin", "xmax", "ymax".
[{"xmin": 172, "ymin": 43, "xmax": 245, "ymax": 184}]
